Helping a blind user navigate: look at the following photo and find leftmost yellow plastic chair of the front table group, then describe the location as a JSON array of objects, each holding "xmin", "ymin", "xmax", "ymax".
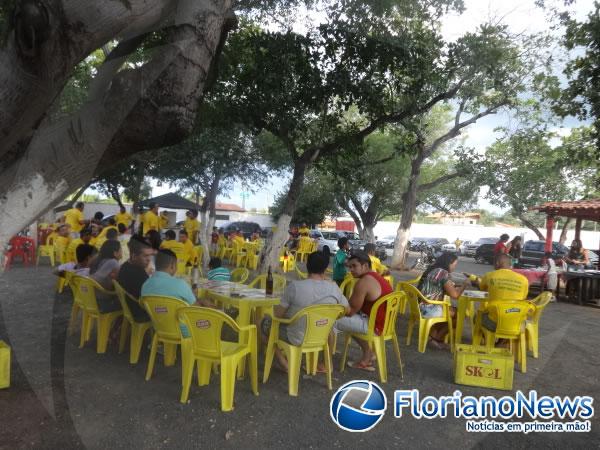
[{"xmin": 70, "ymin": 275, "xmax": 123, "ymax": 353}]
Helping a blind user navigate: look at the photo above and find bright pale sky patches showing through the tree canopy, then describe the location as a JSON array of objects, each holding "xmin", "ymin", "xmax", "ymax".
[{"xmin": 153, "ymin": 0, "xmax": 594, "ymax": 212}]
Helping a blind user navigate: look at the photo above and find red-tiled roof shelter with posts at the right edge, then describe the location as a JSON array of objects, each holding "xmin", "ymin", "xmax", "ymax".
[{"xmin": 530, "ymin": 198, "xmax": 600, "ymax": 252}]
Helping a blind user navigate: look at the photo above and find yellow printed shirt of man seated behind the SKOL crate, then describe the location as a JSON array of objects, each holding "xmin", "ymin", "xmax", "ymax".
[{"xmin": 479, "ymin": 269, "xmax": 529, "ymax": 322}]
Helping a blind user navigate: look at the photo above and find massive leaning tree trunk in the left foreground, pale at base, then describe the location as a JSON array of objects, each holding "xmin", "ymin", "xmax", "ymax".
[{"xmin": 0, "ymin": 0, "xmax": 230, "ymax": 253}]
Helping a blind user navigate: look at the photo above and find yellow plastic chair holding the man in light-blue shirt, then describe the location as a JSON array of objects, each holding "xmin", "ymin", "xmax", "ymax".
[{"xmin": 140, "ymin": 295, "xmax": 189, "ymax": 381}]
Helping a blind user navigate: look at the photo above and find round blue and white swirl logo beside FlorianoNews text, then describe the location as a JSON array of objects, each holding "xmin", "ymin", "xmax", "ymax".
[{"xmin": 329, "ymin": 380, "xmax": 387, "ymax": 432}]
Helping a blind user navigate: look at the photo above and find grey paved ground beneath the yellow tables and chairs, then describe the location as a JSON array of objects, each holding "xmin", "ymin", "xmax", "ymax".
[{"xmin": 0, "ymin": 259, "xmax": 600, "ymax": 450}]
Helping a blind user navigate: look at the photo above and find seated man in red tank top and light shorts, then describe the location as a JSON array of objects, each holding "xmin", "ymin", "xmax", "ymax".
[{"xmin": 335, "ymin": 251, "xmax": 392, "ymax": 372}]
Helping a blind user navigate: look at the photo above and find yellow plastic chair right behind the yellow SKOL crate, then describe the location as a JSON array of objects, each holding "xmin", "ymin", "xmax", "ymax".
[{"xmin": 473, "ymin": 300, "xmax": 535, "ymax": 373}]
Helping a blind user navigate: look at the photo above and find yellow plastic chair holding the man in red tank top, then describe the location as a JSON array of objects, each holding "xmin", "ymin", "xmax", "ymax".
[{"xmin": 340, "ymin": 292, "xmax": 406, "ymax": 383}]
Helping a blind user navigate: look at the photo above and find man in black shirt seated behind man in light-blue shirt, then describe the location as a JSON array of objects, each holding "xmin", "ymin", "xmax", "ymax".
[{"xmin": 117, "ymin": 236, "xmax": 153, "ymax": 322}]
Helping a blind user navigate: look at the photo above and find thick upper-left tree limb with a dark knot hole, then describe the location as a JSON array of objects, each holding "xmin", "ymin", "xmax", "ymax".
[{"xmin": 0, "ymin": 0, "xmax": 178, "ymax": 167}]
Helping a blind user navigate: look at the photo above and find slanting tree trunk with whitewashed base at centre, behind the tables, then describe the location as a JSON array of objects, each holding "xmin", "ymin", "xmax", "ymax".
[{"xmin": 260, "ymin": 160, "xmax": 307, "ymax": 273}]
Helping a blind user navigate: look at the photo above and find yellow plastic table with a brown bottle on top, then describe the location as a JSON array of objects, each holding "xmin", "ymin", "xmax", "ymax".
[{"xmin": 197, "ymin": 280, "xmax": 280, "ymax": 378}]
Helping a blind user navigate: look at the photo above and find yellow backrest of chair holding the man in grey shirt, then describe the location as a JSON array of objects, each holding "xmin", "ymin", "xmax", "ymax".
[{"xmin": 290, "ymin": 305, "xmax": 345, "ymax": 347}]
